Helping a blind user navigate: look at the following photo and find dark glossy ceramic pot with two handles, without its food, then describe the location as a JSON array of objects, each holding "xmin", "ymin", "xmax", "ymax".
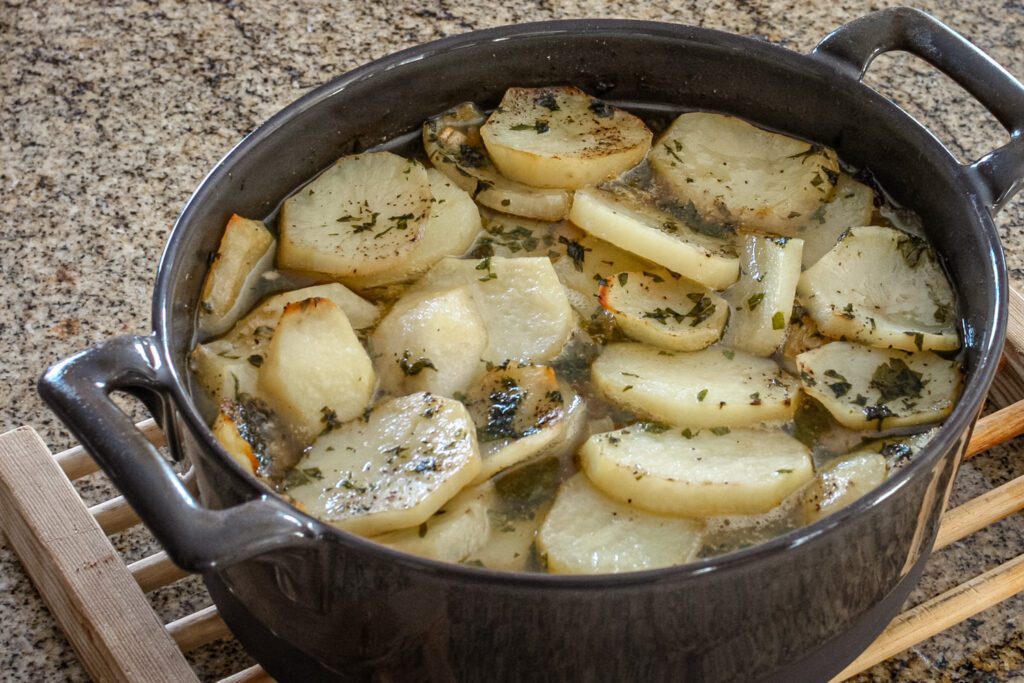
[{"xmin": 40, "ymin": 9, "xmax": 1024, "ymax": 681}]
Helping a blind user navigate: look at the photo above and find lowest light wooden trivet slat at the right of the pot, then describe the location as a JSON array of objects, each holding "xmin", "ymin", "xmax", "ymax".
[{"xmin": 835, "ymin": 555, "xmax": 1024, "ymax": 681}]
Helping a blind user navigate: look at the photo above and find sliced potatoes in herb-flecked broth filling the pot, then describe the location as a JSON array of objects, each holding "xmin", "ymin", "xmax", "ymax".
[{"xmin": 191, "ymin": 87, "xmax": 962, "ymax": 573}]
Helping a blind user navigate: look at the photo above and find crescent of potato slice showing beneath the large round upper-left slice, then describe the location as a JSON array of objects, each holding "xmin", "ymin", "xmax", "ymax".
[{"xmin": 345, "ymin": 168, "xmax": 480, "ymax": 290}]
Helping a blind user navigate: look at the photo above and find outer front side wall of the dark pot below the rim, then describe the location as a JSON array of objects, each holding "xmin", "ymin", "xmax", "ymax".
[{"xmin": 188, "ymin": 428, "xmax": 955, "ymax": 681}]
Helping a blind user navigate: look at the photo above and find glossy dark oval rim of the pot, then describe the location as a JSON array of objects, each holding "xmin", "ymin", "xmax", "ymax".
[{"xmin": 153, "ymin": 19, "xmax": 1009, "ymax": 589}]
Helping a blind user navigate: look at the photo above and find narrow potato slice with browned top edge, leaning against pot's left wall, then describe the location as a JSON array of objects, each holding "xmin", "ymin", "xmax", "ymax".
[{"xmin": 199, "ymin": 214, "xmax": 274, "ymax": 335}]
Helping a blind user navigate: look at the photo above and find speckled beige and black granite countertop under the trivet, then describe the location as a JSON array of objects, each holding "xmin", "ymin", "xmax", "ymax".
[{"xmin": 0, "ymin": 0, "xmax": 1024, "ymax": 681}]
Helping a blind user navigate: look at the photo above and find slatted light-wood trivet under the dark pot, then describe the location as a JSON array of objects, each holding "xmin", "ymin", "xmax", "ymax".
[{"xmin": 6, "ymin": 291, "xmax": 1024, "ymax": 683}]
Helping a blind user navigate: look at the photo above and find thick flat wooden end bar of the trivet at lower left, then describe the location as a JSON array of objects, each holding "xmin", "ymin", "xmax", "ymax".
[{"xmin": 0, "ymin": 427, "xmax": 198, "ymax": 681}]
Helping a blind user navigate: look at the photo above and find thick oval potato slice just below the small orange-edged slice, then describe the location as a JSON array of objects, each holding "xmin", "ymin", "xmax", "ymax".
[{"xmin": 591, "ymin": 344, "xmax": 799, "ymax": 429}]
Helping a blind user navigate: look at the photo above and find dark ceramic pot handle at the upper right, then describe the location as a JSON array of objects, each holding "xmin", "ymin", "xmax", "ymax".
[{"xmin": 811, "ymin": 7, "xmax": 1024, "ymax": 213}]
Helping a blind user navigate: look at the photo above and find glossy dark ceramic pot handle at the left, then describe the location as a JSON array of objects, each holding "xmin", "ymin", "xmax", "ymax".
[{"xmin": 39, "ymin": 337, "xmax": 315, "ymax": 572}]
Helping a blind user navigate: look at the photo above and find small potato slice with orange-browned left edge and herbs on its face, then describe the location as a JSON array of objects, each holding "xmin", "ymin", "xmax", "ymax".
[{"xmin": 600, "ymin": 271, "xmax": 729, "ymax": 351}]
